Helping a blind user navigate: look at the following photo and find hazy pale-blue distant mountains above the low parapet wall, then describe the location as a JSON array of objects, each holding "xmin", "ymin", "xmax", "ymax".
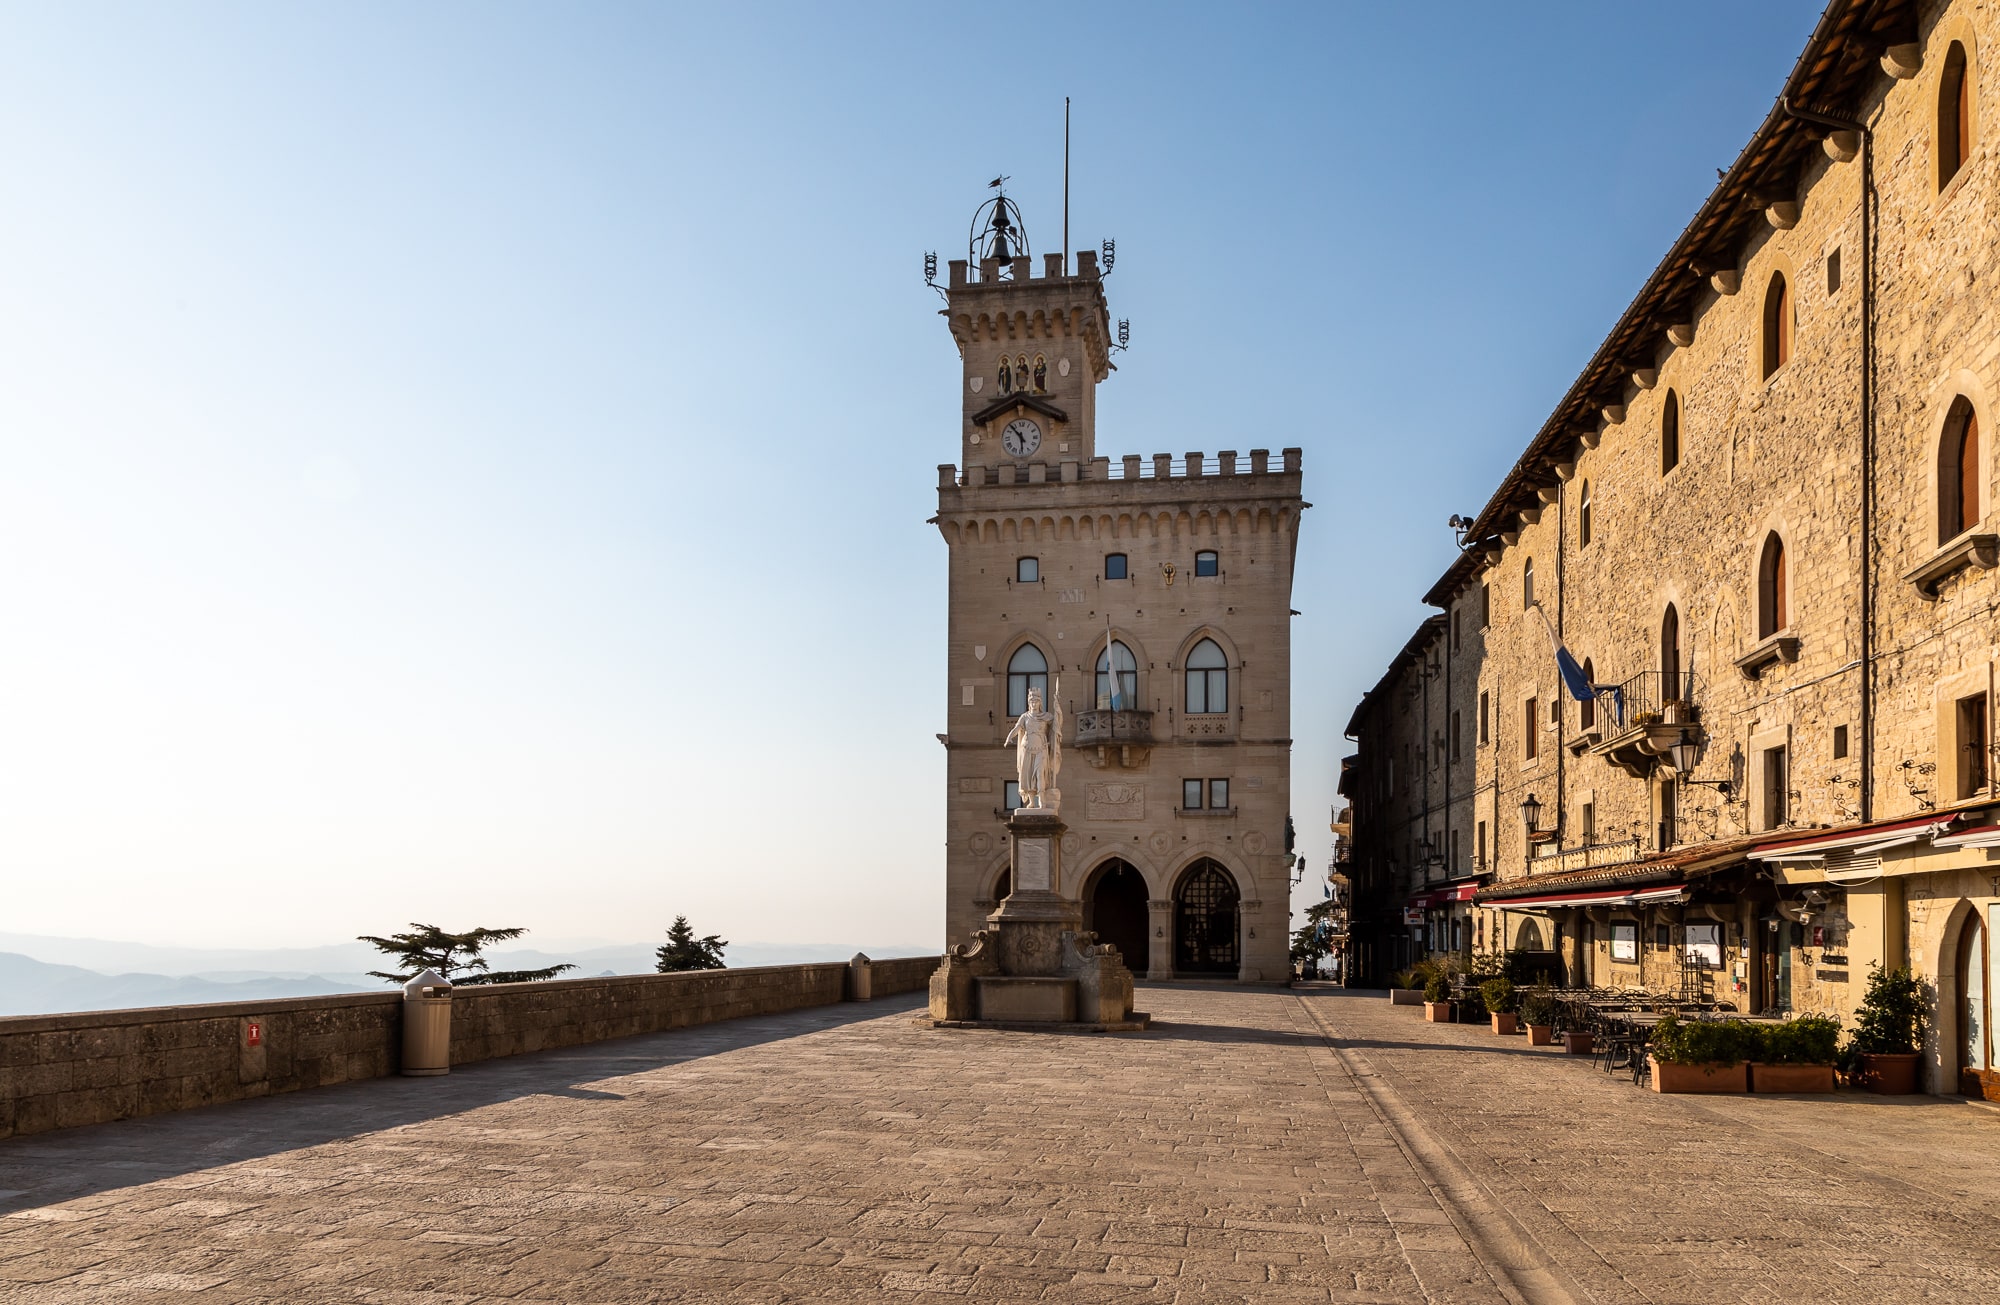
[{"xmin": 0, "ymin": 933, "xmax": 936, "ymax": 1015}]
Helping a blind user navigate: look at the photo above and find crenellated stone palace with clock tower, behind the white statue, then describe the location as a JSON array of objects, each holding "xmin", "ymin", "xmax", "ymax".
[{"xmin": 932, "ymin": 198, "xmax": 1306, "ymax": 981}]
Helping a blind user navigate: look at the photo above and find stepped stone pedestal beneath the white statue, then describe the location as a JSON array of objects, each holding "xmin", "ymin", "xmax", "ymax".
[{"xmin": 930, "ymin": 807, "xmax": 1148, "ymax": 1029}]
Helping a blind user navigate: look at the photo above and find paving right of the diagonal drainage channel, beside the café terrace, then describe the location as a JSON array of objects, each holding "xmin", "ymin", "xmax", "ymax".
[{"xmin": 1304, "ymin": 989, "xmax": 2000, "ymax": 1305}]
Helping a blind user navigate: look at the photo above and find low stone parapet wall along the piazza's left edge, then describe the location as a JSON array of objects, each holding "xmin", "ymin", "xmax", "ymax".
[{"xmin": 0, "ymin": 957, "xmax": 938, "ymax": 1137}]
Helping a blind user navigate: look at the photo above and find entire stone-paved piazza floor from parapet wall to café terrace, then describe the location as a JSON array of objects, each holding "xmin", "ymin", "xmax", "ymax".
[{"xmin": 0, "ymin": 987, "xmax": 2000, "ymax": 1305}]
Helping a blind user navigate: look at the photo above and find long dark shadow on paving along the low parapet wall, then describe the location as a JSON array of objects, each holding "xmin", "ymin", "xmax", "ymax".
[{"xmin": 0, "ymin": 993, "xmax": 926, "ymax": 1219}]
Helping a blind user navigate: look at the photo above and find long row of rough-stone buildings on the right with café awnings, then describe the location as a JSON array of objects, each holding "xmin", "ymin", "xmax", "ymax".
[{"xmin": 1342, "ymin": 0, "xmax": 2000, "ymax": 1095}]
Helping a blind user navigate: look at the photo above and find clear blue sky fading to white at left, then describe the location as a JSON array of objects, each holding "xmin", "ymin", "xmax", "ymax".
[{"xmin": 0, "ymin": 0, "xmax": 1818, "ymax": 945}]
